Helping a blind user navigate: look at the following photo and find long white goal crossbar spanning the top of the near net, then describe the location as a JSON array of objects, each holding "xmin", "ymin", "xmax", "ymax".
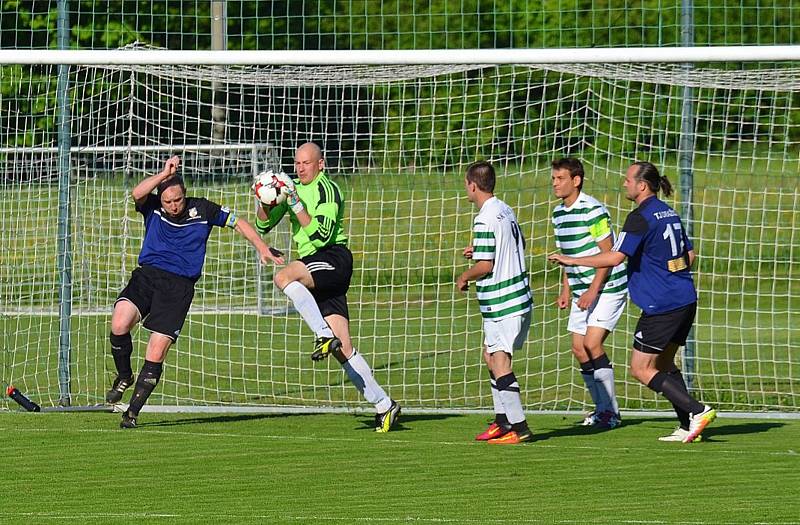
[{"xmin": 0, "ymin": 45, "xmax": 800, "ymax": 66}]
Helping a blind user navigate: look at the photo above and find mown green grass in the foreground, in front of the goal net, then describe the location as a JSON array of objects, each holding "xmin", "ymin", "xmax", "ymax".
[{"xmin": 0, "ymin": 413, "xmax": 800, "ymax": 525}]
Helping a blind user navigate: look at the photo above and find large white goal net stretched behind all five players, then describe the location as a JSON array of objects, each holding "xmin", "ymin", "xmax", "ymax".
[{"xmin": 0, "ymin": 53, "xmax": 800, "ymax": 412}]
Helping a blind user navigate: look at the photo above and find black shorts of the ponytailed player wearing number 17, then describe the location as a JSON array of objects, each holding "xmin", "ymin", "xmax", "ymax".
[{"xmin": 633, "ymin": 303, "xmax": 697, "ymax": 354}]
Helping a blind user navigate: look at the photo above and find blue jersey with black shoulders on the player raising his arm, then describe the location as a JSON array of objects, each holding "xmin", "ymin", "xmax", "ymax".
[{"xmin": 136, "ymin": 193, "xmax": 237, "ymax": 280}]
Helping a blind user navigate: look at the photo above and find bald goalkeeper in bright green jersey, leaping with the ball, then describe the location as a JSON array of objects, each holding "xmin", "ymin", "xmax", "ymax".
[{"xmin": 256, "ymin": 142, "xmax": 400, "ymax": 432}]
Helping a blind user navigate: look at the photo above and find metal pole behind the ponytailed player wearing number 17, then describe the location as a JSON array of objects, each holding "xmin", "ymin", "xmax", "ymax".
[{"xmin": 678, "ymin": 0, "xmax": 696, "ymax": 392}]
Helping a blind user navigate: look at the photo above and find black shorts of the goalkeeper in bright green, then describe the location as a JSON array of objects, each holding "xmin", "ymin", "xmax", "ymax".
[{"xmin": 300, "ymin": 244, "xmax": 353, "ymax": 319}]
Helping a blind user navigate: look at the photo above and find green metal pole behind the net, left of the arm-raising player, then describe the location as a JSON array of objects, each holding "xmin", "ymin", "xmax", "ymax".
[{"xmin": 56, "ymin": 0, "xmax": 72, "ymax": 406}]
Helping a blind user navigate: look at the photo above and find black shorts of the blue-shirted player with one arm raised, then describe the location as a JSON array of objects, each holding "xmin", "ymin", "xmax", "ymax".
[{"xmin": 114, "ymin": 266, "xmax": 194, "ymax": 342}]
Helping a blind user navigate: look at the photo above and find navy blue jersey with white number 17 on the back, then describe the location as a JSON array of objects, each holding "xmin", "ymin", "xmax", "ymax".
[{"xmin": 614, "ymin": 196, "xmax": 697, "ymax": 314}]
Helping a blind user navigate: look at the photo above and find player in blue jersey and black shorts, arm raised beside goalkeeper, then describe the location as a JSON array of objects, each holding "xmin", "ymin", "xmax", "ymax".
[{"xmin": 106, "ymin": 155, "xmax": 283, "ymax": 428}]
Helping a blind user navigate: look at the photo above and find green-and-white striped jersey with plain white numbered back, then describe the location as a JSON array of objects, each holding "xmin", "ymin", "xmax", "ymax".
[{"xmin": 472, "ymin": 197, "xmax": 533, "ymax": 321}]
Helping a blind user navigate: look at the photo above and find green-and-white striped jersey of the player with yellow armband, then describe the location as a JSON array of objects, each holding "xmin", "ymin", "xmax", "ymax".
[{"xmin": 553, "ymin": 193, "xmax": 628, "ymax": 298}]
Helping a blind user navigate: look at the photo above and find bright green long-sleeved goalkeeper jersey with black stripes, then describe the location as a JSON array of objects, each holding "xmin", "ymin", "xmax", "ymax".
[{"xmin": 256, "ymin": 171, "xmax": 347, "ymax": 257}]
